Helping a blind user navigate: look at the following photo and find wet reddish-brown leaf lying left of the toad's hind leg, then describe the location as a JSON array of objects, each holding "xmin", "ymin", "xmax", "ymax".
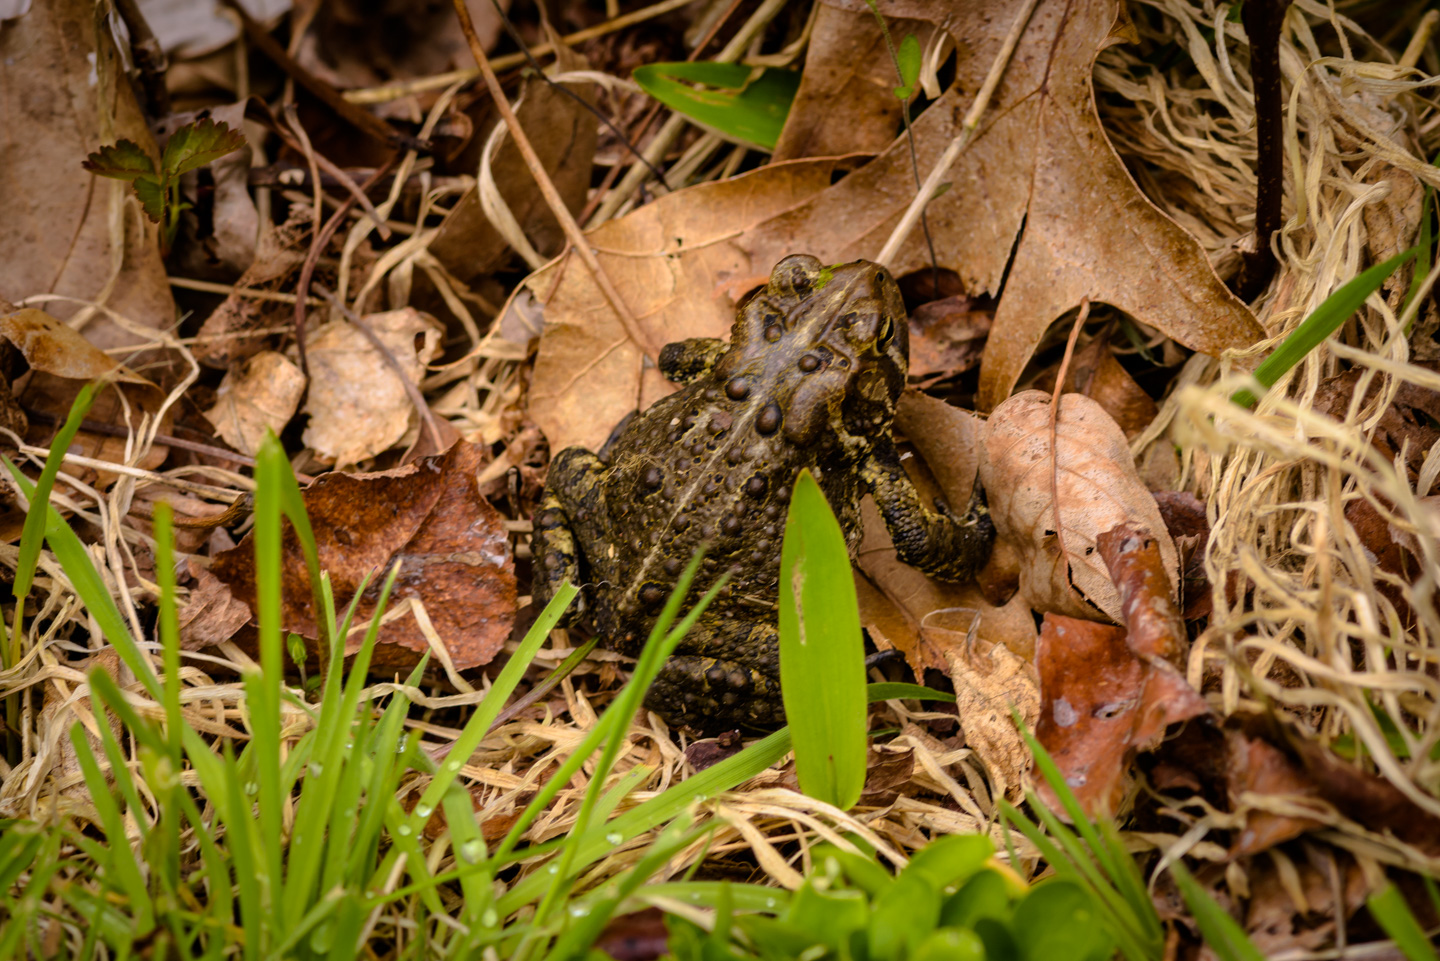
[{"xmin": 210, "ymin": 442, "xmax": 516, "ymax": 673}]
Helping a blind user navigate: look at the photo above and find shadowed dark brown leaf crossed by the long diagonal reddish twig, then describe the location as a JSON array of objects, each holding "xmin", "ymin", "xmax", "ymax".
[{"xmin": 429, "ymin": 70, "xmax": 598, "ymax": 285}]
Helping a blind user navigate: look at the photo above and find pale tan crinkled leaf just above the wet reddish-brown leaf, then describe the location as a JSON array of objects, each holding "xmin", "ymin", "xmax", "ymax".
[{"xmin": 301, "ymin": 307, "xmax": 445, "ymax": 467}]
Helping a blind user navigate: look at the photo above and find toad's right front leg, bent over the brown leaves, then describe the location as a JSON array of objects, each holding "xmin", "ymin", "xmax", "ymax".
[{"xmin": 861, "ymin": 439, "xmax": 995, "ymax": 581}]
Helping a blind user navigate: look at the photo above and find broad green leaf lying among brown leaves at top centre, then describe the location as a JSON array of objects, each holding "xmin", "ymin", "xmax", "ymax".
[{"xmin": 634, "ymin": 62, "xmax": 801, "ymax": 150}]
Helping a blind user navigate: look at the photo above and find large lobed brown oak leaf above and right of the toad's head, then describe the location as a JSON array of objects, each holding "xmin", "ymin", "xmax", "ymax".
[{"xmin": 737, "ymin": 0, "xmax": 1264, "ymax": 409}]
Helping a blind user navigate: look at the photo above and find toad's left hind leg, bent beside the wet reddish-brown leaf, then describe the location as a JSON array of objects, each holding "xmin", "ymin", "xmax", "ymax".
[{"xmin": 530, "ymin": 447, "xmax": 605, "ymax": 622}]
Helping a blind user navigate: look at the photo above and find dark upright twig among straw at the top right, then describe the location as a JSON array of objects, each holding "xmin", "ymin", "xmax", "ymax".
[{"xmin": 1218, "ymin": 0, "xmax": 1290, "ymax": 301}]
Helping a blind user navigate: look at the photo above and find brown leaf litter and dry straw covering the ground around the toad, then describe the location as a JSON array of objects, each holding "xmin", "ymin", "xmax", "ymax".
[{"xmin": 0, "ymin": 0, "xmax": 1440, "ymax": 961}]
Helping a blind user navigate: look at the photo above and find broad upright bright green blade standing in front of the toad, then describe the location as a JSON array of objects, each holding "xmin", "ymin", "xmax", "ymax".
[{"xmin": 779, "ymin": 470, "xmax": 865, "ymax": 810}]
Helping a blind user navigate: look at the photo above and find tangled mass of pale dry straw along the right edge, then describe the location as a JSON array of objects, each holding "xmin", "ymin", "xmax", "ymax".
[{"xmin": 1096, "ymin": 0, "xmax": 1440, "ymax": 870}]
